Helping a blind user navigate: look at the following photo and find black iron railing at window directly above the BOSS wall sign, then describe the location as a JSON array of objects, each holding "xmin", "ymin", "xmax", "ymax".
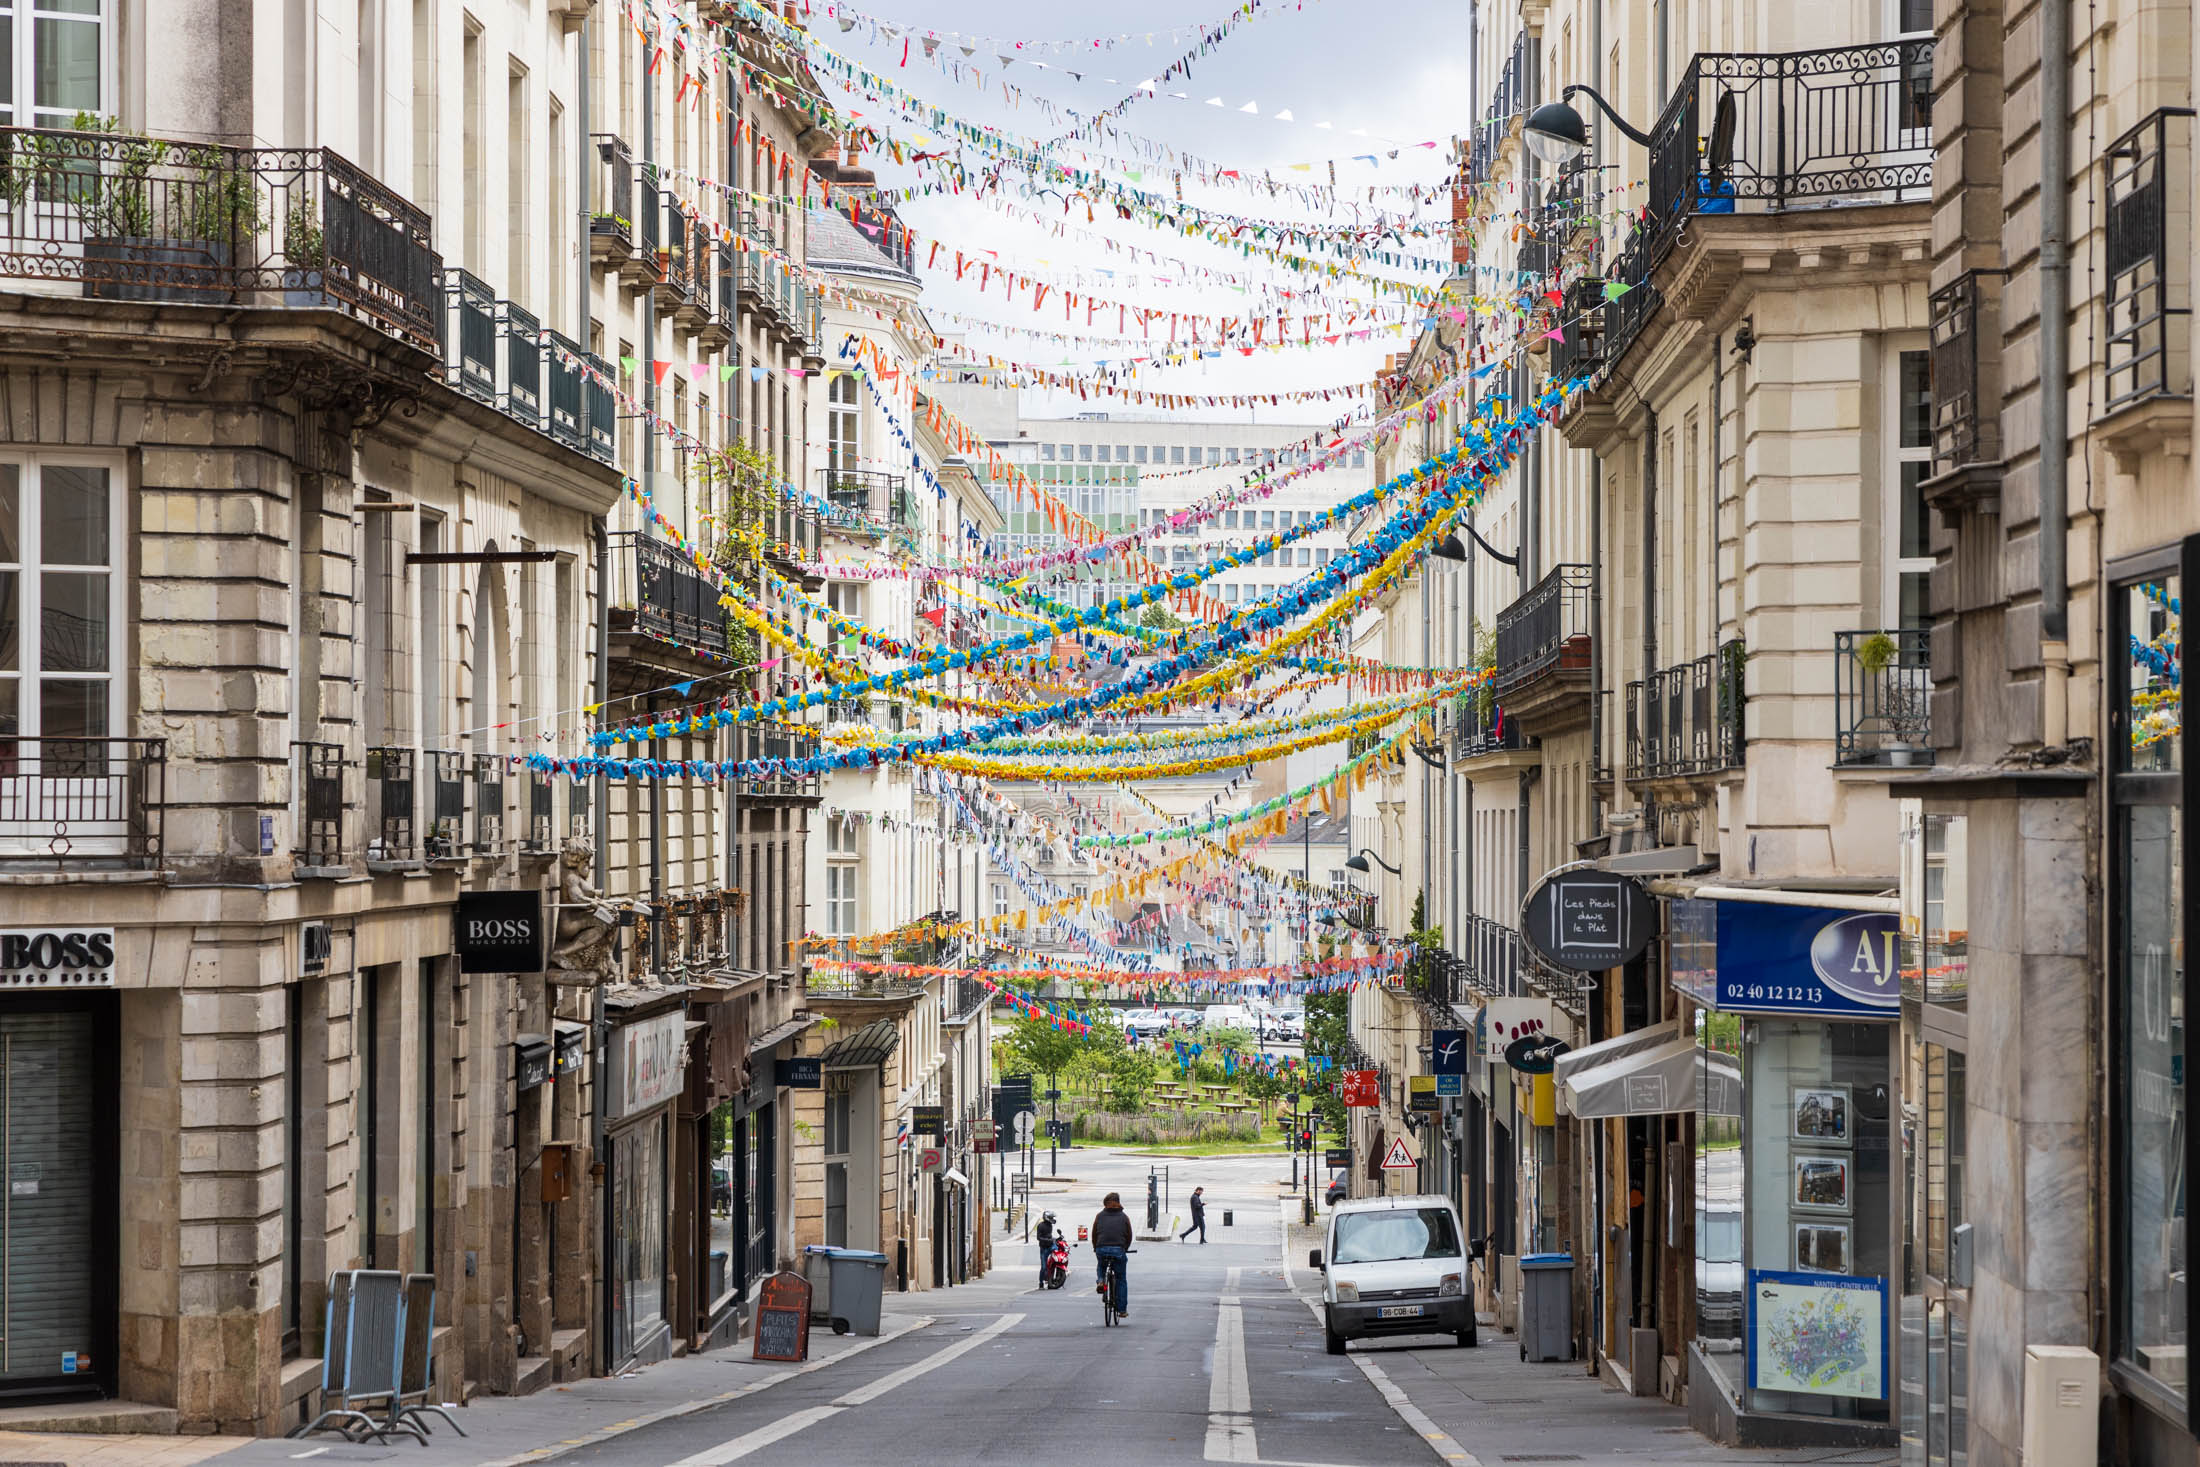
[{"xmin": 0, "ymin": 735, "xmax": 167, "ymax": 869}]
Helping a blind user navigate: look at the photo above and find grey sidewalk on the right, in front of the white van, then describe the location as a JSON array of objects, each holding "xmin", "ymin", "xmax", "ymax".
[{"xmin": 1283, "ymin": 1207, "xmax": 1896, "ymax": 1467}]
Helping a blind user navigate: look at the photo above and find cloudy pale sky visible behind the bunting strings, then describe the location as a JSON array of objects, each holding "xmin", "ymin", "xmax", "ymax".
[{"xmin": 807, "ymin": 0, "xmax": 1470, "ymax": 422}]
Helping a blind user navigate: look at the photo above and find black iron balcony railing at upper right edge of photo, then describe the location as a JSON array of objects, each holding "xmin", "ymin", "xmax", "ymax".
[{"xmin": 2101, "ymin": 108, "xmax": 2193, "ymax": 409}]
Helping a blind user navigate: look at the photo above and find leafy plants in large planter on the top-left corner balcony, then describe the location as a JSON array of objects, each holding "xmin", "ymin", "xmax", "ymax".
[{"xmin": 70, "ymin": 112, "xmax": 262, "ymax": 304}]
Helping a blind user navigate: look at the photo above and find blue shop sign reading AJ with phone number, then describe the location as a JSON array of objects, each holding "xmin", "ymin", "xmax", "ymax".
[{"xmin": 1668, "ymin": 902, "xmax": 1901, "ymax": 1018}]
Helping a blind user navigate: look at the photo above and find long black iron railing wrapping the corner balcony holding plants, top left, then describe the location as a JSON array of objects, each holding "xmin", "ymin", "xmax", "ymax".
[{"xmin": 0, "ymin": 128, "xmax": 442, "ymax": 352}]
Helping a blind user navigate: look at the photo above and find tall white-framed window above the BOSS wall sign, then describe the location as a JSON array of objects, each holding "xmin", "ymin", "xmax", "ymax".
[{"xmin": 0, "ymin": 457, "xmax": 121, "ymax": 747}]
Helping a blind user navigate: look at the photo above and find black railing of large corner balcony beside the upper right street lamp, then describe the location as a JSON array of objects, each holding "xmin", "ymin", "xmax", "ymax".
[{"xmin": 1606, "ymin": 37, "xmax": 1934, "ymax": 361}]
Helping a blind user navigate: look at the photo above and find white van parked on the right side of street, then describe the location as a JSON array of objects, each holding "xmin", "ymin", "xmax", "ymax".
[{"xmin": 1307, "ymin": 1196, "xmax": 1474, "ymax": 1355}]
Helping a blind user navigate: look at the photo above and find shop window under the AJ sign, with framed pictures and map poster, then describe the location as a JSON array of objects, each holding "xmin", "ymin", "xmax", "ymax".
[{"xmin": 1742, "ymin": 1018, "xmax": 1894, "ymax": 1421}]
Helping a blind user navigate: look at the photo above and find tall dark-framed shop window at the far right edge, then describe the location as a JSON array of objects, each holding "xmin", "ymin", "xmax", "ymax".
[{"xmin": 2110, "ymin": 572, "xmax": 2187, "ymax": 1399}]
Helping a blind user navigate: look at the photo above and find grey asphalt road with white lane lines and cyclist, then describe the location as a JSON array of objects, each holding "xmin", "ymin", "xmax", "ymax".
[{"xmin": 559, "ymin": 1152, "xmax": 1439, "ymax": 1467}]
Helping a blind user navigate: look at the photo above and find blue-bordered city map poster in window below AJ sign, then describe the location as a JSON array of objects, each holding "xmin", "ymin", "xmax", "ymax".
[{"xmin": 1749, "ymin": 1269, "xmax": 1888, "ymax": 1401}]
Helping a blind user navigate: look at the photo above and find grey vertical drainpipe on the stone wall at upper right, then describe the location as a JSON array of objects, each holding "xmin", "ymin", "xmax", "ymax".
[{"xmin": 2039, "ymin": 0, "xmax": 2070, "ymax": 748}]
